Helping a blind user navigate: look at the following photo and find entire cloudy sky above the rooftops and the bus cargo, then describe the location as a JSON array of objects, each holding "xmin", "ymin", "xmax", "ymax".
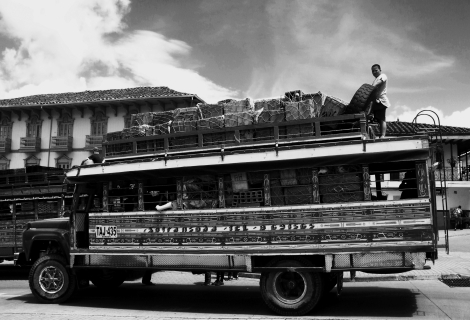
[{"xmin": 0, "ymin": 0, "xmax": 470, "ymax": 127}]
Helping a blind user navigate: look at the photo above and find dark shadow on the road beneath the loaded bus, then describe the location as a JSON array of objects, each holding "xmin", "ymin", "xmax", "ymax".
[{"xmin": 9, "ymin": 281, "xmax": 419, "ymax": 318}]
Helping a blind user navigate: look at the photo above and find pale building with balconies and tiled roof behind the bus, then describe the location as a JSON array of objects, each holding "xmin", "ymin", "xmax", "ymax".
[{"xmin": 0, "ymin": 87, "xmax": 203, "ymax": 170}]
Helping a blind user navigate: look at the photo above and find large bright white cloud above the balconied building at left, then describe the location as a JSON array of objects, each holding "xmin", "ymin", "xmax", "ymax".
[{"xmin": 0, "ymin": 0, "xmax": 237, "ymax": 101}]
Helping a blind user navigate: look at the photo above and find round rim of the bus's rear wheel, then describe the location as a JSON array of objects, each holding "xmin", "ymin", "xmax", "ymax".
[{"xmin": 273, "ymin": 272, "xmax": 307, "ymax": 304}]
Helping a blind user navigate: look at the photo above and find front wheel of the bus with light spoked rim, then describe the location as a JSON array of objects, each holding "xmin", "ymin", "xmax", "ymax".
[{"xmin": 29, "ymin": 254, "xmax": 76, "ymax": 303}]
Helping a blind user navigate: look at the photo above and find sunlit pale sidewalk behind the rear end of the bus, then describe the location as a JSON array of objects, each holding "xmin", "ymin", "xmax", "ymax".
[{"xmin": 240, "ymin": 229, "xmax": 470, "ymax": 282}]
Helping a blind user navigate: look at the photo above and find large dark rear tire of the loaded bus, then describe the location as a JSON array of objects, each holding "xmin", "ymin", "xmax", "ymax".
[{"xmin": 260, "ymin": 259, "xmax": 323, "ymax": 316}]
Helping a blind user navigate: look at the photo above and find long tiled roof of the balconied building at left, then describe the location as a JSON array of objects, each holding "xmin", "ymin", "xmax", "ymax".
[{"xmin": 0, "ymin": 87, "xmax": 200, "ymax": 107}]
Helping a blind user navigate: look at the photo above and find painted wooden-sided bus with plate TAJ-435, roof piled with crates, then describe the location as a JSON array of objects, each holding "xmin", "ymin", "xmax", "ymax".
[{"xmin": 17, "ymin": 85, "xmax": 438, "ymax": 316}]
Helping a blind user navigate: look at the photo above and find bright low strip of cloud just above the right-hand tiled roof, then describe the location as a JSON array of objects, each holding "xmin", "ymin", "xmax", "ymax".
[{"xmin": 387, "ymin": 105, "xmax": 470, "ymax": 128}]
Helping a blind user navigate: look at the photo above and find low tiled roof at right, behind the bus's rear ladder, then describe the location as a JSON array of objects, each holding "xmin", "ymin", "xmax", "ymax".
[{"xmin": 380, "ymin": 121, "xmax": 470, "ymax": 136}]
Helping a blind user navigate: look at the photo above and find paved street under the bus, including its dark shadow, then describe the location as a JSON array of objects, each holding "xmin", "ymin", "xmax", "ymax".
[{"xmin": 0, "ymin": 231, "xmax": 470, "ymax": 320}]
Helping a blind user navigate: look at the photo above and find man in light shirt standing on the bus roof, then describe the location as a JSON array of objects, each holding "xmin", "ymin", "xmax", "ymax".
[{"xmin": 371, "ymin": 64, "xmax": 390, "ymax": 138}]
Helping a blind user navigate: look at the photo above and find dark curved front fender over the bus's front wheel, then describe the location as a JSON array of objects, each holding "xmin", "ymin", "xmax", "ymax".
[{"xmin": 23, "ymin": 229, "xmax": 70, "ymax": 263}]
